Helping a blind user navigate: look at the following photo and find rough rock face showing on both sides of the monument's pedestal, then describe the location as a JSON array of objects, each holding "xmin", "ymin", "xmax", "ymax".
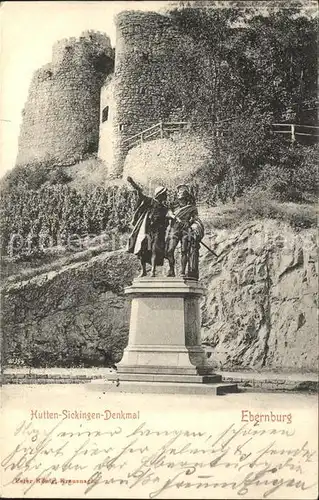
[{"xmin": 2, "ymin": 220, "xmax": 318, "ymax": 372}]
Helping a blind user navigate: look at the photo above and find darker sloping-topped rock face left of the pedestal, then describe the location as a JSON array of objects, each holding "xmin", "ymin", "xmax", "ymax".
[{"xmin": 2, "ymin": 252, "xmax": 137, "ymax": 366}]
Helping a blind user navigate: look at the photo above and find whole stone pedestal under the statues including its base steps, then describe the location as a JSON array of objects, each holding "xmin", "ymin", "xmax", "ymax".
[{"xmin": 99, "ymin": 277, "xmax": 237, "ymax": 394}]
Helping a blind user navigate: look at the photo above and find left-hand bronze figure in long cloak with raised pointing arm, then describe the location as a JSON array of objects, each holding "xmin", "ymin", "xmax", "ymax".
[{"xmin": 127, "ymin": 177, "xmax": 168, "ymax": 277}]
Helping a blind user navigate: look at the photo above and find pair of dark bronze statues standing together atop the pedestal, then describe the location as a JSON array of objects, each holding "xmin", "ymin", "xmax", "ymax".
[{"xmin": 127, "ymin": 177, "xmax": 204, "ymax": 280}]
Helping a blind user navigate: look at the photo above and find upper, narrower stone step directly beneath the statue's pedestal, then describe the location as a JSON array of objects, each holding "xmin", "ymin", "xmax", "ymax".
[{"xmin": 107, "ymin": 372, "xmax": 222, "ymax": 384}]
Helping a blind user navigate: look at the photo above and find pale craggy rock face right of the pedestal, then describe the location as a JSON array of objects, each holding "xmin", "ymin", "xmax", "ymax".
[{"xmin": 201, "ymin": 221, "xmax": 318, "ymax": 371}]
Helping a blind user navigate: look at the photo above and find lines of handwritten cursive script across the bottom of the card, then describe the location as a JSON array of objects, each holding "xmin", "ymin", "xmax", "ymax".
[{"xmin": 2, "ymin": 419, "xmax": 317, "ymax": 498}]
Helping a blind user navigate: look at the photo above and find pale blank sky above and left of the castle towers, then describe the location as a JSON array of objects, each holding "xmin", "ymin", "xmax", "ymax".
[{"xmin": 0, "ymin": 0, "xmax": 167, "ymax": 176}]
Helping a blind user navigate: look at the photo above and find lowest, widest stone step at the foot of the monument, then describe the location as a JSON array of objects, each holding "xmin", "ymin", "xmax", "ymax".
[{"xmin": 88, "ymin": 380, "xmax": 238, "ymax": 396}]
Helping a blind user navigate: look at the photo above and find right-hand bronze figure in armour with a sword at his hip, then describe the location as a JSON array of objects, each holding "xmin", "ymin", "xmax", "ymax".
[{"xmin": 166, "ymin": 184, "xmax": 204, "ymax": 279}]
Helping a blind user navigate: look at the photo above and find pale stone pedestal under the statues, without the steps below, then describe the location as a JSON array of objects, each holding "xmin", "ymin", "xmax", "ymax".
[{"xmin": 118, "ymin": 278, "xmax": 211, "ymax": 375}]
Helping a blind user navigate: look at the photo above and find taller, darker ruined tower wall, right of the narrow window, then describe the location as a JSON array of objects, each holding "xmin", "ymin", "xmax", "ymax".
[{"xmin": 113, "ymin": 11, "xmax": 218, "ymax": 176}]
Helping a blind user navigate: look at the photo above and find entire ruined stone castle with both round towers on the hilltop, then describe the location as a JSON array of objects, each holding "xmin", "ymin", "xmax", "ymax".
[{"xmin": 17, "ymin": 11, "xmax": 225, "ymax": 177}]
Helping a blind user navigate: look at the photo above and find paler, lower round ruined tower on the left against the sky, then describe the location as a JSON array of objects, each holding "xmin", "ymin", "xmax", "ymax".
[{"xmin": 17, "ymin": 32, "xmax": 114, "ymax": 165}]
